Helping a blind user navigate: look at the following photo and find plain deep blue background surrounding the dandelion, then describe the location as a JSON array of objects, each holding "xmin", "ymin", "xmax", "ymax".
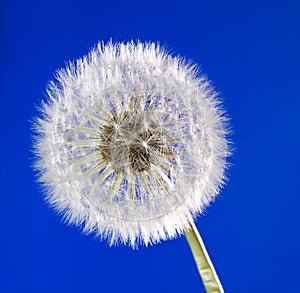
[{"xmin": 0, "ymin": 0, "xmax": 300, "ymax": 293}]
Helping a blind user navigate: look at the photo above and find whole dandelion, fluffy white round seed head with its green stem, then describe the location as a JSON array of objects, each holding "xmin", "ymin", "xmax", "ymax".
[{"xmin": 34, "ymin": 42, "xmax": 228, "ymax": 292}]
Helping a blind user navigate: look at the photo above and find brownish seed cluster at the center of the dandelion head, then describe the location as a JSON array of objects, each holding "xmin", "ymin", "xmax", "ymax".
[{"xmin": 100, "ymin": 112, "xmax": 163, "ymax": 174}]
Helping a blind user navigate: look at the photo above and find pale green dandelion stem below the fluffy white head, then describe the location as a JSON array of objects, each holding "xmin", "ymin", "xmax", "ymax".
[{"xmin": 184, "ymin": 222, "xmax": 224, "ymax": 293}]
